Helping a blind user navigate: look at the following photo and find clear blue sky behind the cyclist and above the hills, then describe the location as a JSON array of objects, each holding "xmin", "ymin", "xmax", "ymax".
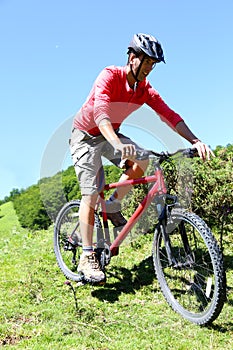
[{"xmin": 0, "ymin": 0, "xmax": 233, "ymax": 199}]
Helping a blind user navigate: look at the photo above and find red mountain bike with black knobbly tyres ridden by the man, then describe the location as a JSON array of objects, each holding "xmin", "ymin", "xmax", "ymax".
[{"xmin": 54, "ymin": 149, "xmax": 226, "ymax": 325}]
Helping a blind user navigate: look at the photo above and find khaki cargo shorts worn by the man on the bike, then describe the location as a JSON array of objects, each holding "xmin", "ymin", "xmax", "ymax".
[{"xmin": 70, "ymin": 129, "xmax": 142, "ymax": 195}]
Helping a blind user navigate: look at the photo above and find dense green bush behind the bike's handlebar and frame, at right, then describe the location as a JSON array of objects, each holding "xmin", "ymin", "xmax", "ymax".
[{"xmin": 123, "ymin": 145, "xmax": 233, "ymax": 238}]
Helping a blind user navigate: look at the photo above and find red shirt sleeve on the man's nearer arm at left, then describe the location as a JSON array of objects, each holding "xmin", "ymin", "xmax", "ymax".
[{"xmin": 94, "ymin": 67, "xmax": 114, "ymax": 126}]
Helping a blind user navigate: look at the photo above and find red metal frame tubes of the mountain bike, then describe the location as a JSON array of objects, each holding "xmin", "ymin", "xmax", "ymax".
[{"xmin": 99, "ymin": 168, "xmax": 167, "ymax": 256}]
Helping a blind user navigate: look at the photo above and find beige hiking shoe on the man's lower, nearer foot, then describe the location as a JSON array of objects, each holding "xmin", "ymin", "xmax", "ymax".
[{"xmin": 77, "ymin": 252, "xmax": 106, "ymax": 283}]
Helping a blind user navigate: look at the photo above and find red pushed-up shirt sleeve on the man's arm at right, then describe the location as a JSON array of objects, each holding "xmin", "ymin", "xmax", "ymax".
[{"xmin": 146, "ymin": 86, "xmax": 183, "ymax": 129}]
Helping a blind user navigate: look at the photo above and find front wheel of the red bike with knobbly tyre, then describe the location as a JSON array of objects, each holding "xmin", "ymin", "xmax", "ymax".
[{"xmin": 152, "ymin": 209, "xmax": 226, "ymax": 325}]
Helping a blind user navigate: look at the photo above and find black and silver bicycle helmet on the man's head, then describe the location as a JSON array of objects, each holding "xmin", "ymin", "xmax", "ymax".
[{"xmin": 128, "ymin": 33, "xmax": 165, "ymax": 62}]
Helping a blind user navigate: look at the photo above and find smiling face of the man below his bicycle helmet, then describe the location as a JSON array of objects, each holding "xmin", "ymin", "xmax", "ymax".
[{"xmin": 130, "ymin": 54, "xmax": 156, "ymax": 81}]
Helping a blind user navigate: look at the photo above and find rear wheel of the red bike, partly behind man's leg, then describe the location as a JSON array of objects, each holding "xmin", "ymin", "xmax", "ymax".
[{"xmin": 54, "ymin": 200, "xmax": 101, "ymax": 282}]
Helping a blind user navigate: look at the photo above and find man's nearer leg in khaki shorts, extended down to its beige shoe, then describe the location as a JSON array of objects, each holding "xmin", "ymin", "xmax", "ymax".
[{"xmin": 70, "ymin": 129, "xmax": 106, "ymax": 282}]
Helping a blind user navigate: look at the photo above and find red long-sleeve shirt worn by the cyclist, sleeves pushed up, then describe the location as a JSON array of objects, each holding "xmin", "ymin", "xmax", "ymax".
[{"xmin": 73, "ymin": 66, "xmax": 183, "ymax": 135}]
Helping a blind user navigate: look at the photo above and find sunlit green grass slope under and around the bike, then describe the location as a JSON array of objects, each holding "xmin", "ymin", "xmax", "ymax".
[{"xmin": 0, "ymin": 203, "xmax": 233, "ymax": 350}]
